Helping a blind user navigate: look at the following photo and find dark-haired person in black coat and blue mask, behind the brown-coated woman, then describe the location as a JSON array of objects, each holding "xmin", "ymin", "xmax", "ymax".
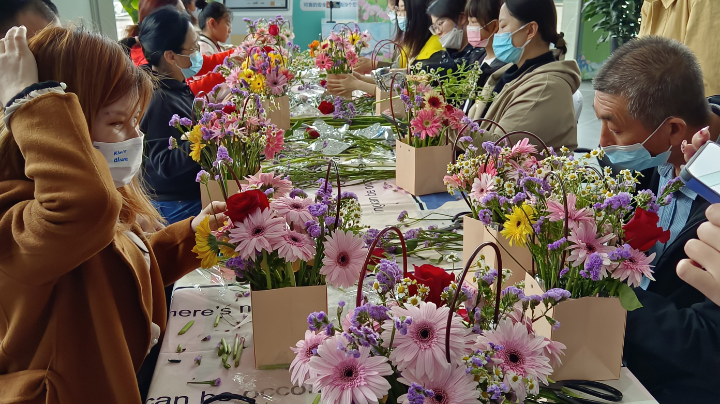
[{"xmin": 139, "ymin": 7, "xmax": 202, "ymax": 223}]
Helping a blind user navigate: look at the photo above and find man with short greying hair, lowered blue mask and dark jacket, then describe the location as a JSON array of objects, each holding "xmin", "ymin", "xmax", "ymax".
[{"xmin": 594, "ymin": 37, "xmax": 720, "ymax": 403}]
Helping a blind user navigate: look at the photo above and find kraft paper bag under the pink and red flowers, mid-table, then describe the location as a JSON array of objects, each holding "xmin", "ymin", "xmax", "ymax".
[{"xmin": 395, "ymin": 140, "xmax": 452, "ymax": 196}]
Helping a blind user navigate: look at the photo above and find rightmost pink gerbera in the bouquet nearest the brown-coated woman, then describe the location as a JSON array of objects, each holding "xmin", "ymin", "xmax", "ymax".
[{"xmin": 320, "ymin": 230, "xmax": 367, "ymax": 288}]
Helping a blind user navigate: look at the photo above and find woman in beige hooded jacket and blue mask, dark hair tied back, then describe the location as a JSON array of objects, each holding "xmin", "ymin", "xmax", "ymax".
[{"xmin": 469, "ymin": 0, "xmax": 580, "ymax": 150}]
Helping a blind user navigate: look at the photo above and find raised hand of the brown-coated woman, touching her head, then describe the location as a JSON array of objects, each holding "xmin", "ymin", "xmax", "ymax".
[{"xmin": 0, "ymin": 27, "xmax": 38, "ymax": 106}]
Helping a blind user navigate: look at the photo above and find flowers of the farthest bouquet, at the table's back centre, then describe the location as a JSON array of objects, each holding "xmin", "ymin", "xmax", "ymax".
[{"xmin": 310, "ymin": 24, "xmax": 370, "ymax": 74}]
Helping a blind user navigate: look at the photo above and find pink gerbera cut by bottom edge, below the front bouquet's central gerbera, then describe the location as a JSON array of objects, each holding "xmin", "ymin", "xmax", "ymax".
[{"xmin": 398, "ymin": 366, "xmax": 480, "ymax": 404}]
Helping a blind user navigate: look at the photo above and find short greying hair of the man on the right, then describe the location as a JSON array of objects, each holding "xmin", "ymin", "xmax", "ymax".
[{"xmin": 593, "ymin": 36, "xmax": 710, "ymax": 131}]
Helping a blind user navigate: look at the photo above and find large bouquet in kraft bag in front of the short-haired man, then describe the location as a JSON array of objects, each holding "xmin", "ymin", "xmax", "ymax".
[{"xmin": 448, "ymin": 134, "xmax": 681, "ymax": 380}]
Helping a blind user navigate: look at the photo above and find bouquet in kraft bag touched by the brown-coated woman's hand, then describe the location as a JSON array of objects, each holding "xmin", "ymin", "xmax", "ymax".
[{"xmin": 194, "ymin": 163, "xmax": 366, "ymax": 369}]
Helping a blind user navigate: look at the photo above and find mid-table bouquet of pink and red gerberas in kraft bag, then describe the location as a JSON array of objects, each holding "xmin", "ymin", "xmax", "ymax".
[{"xmin": 390, "ymin": 75, "xmax": 471, "ymax": 196}]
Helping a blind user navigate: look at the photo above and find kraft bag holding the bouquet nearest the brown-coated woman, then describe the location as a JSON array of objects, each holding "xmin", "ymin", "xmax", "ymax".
[{"xmin": 250, "ymin": 285, "xmax": 327, "ymax": 369}]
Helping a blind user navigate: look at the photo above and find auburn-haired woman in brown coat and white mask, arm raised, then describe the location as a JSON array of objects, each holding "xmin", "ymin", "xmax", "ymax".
[{"xmin": 0, "ymin": 27, "xmax": 225, "ymax": 404}]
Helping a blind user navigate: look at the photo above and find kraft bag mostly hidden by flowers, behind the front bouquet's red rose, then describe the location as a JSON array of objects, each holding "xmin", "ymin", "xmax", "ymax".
[{"xmin": 463, "ymin": 216, "xmax": 532, "ymax": 287}]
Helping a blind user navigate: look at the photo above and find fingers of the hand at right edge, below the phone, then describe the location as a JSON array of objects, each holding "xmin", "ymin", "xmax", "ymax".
[{"xmin": 676, "ymin": 204, "xmax": 720, "ymax": 305}]
